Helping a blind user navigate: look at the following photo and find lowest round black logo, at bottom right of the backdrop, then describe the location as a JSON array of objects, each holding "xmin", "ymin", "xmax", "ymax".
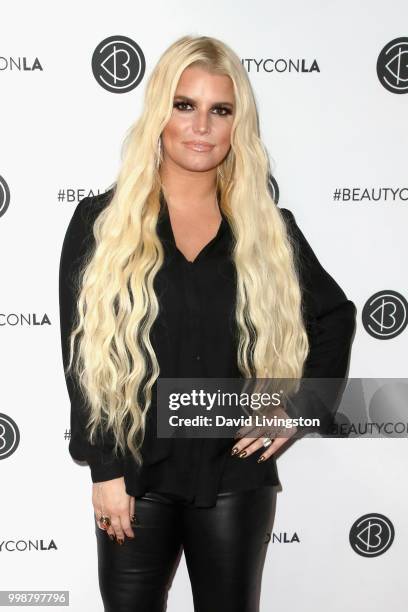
[{"xmin": 349, "ymin": 513, "xmax": 395, "ymax": 557}]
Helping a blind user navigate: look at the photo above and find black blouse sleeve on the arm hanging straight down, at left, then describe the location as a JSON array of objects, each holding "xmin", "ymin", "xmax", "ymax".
[{"xmin": 59, "ymin": 197, "xmax": 124, "ymax": 482}]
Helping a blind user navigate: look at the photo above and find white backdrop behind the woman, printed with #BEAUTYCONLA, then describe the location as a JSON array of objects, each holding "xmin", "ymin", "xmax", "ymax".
[{"xmin": 0, "ymin": 0, "xmax": 408, "ymax": 612}]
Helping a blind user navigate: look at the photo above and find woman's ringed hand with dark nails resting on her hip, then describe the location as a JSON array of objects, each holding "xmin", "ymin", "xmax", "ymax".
[{"xmin": 231, "ymin": 407, "xmax": 297, "ymax": 463}]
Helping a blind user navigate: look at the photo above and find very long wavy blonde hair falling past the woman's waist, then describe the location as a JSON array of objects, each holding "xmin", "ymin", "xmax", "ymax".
[{"xmin": 67, "ymin": 36, "xmax": 309, "ymax": 465}]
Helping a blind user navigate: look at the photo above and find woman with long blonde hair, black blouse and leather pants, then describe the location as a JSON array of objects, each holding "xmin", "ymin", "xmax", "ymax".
[{"xmin": 60, "ymin": 36, "xmax": 355, "ymax": 612}]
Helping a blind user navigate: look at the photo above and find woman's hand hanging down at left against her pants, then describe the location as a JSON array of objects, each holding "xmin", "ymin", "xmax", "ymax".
[{"xmin": 92, "ymin": 476, "xmax": 135, "ymax": 544}]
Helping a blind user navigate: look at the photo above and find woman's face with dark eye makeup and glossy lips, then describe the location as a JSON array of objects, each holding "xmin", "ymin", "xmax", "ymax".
[{"xmin": 162, "ymin": 66, "xmax": 234, "ymax": 172}]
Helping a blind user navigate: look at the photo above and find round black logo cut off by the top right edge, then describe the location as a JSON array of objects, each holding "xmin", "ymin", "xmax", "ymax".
[{"xmin": 377, "ymin": 36, "xmax": 408, "ymax": 93}]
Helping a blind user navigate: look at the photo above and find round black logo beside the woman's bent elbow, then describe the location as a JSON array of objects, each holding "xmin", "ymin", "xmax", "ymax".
[{"xmin": 361, "ymin": 290, "xmax": 408, "ymax": 340}]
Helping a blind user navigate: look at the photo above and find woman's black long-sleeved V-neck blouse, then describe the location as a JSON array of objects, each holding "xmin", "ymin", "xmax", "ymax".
[{"xmin": 59, "ymin": 190, "xmax": 356, "ymax": 507}]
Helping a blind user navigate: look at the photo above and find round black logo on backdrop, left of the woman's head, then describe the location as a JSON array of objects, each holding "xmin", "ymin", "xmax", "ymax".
[{"xmin": 92, "ymin": 36, "xmax": 146, "ymax": 93}]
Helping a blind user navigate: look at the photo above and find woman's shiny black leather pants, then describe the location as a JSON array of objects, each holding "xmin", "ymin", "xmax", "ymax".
[{"xmin": 95, "ymin": 486, "xmax": 275, "ymax": 612}]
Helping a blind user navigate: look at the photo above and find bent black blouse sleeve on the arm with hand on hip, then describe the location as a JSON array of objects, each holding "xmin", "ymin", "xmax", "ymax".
[{"xmin": 280, "ymin": 208, "xmax": 357, "ymax": 434}]
